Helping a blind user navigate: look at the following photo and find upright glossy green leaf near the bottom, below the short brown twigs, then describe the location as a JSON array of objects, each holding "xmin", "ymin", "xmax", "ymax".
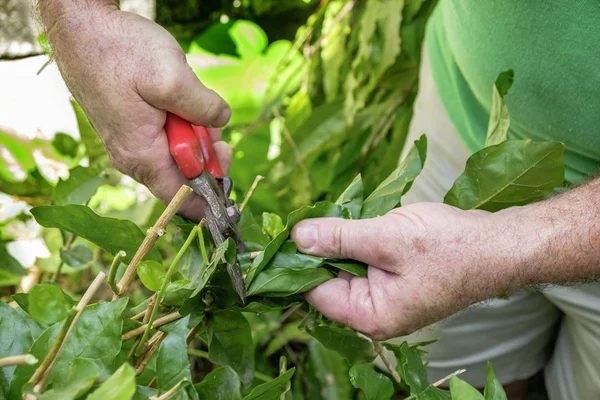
[{"xmin": 156, "ymin": 316, "xmax": 192, "ymax": 393}]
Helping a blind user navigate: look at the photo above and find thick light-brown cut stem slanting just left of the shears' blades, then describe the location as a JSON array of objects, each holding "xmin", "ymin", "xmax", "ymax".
[{"xmin": 117, "ymin": 185, "xmax": 192, "ymax": 297}]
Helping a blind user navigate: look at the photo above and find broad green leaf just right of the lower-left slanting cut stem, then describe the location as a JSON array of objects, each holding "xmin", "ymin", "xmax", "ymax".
[{"xmin": 50, "ymin": 298, "xmax": 128, "ymax": 380}]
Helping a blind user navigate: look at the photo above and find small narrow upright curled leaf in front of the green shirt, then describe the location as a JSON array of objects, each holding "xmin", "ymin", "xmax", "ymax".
[{"xmin": 485, "ymin": 69, "xmax": 515, "ymax": 147}]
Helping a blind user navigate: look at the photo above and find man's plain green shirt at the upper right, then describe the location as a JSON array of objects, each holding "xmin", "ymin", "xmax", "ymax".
[{"xmin": 426, "ymin": 0, "xmax": 600, "ymax": 182}]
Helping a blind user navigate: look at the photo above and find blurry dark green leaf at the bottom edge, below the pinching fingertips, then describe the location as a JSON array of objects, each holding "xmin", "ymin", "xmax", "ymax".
[{"xmin": 306, "ymin": 340, "xmax": 352, "ymax": 400}]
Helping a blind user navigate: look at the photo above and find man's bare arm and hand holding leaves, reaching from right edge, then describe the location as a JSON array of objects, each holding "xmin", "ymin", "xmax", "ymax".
[{"xmin": 292, "ymin": 180, "xmax": 600, "ymax": 339}]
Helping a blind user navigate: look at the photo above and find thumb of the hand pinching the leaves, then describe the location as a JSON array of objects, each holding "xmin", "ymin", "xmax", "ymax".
[{"xmin": 291, "ymin": 217, "xmax": 395, "ymax": 268}]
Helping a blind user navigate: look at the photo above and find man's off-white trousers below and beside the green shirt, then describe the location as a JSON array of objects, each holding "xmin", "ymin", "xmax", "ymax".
[{"xmin": 382, "ymin": 48, "xmax": 600, "ymax": 400}]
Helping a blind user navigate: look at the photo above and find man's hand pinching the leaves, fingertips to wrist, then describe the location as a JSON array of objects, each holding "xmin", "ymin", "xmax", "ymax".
[{"xmin": 292, "ymin": 203, "xmax": 510, "ymax": 340}]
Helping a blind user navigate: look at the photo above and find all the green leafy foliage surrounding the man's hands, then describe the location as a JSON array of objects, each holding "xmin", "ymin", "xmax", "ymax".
[{"xmin": 0, "ymin": 0, "xmax": 564, "ymax": 400}]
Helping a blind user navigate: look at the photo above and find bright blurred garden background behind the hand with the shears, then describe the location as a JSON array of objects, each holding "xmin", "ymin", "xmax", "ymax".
[{"xmin": 0, "ymin": 0, "xmax": 435, "ymax": 290}]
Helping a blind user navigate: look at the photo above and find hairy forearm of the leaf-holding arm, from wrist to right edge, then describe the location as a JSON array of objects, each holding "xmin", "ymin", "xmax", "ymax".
[{"xmin": 488, "ymin": 179, "xmax": 600, "ymax": 290}]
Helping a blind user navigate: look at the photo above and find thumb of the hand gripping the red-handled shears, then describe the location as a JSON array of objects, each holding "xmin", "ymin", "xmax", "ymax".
[{"xmin": 140, "ymin": 50, "xmax": 231, "ymax": 127}]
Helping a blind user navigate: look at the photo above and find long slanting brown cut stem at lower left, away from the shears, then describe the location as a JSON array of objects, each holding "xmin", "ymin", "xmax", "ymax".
[{"xmin": 29, "ymin": 272, "xmax": 106, "ymax": 393}]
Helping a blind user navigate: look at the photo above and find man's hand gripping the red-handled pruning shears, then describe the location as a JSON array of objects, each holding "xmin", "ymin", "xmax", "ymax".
[{"xmin": 39, "ymin": 0, "xmax": 231, "ymax": 219}]
